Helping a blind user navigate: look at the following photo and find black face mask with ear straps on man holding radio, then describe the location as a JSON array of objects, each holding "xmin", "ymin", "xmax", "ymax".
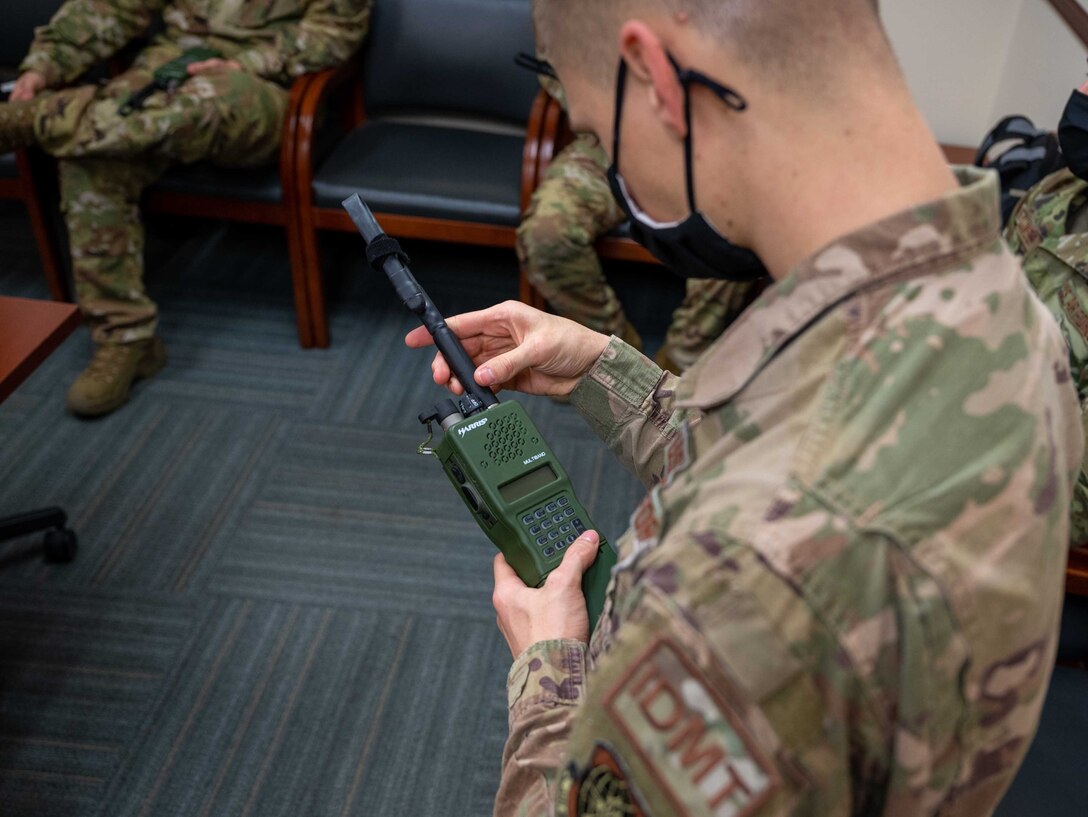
[{"xmin": 608, "ymin": 57, "xmax": 769, "ymax": 282}]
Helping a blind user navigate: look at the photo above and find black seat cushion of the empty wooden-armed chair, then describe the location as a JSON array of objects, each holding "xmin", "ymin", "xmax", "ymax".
[{"xmin": 313, "ymin": 120, "xmax": 524, "ymax": 226}]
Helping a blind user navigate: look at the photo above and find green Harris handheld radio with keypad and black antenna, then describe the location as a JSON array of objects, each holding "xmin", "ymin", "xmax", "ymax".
[{"xmin": 344, "ymin": 195, "xmax": 616, "ymax": 631}]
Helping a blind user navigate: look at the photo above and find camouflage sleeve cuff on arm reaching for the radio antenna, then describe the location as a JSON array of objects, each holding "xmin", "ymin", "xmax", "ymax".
[{"xmin": 571, "ymin": 337, "xmax": 688, "ymax": 486}]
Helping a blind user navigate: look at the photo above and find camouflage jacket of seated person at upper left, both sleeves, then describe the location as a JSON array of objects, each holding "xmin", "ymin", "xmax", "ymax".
[{"xmin": 20, "ymin": 0, "xmax": 372, "ymax": 87}]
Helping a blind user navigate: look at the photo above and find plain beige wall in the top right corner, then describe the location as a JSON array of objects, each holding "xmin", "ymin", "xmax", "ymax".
[{"xmin": 880, "ymin": 0, "xmax": 1088, "ymax": 145}]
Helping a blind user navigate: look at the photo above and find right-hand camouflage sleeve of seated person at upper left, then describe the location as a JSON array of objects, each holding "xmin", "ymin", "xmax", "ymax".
[{"xmin": 234, "ymin": 0, "xmax": 372, "ymax": 83}]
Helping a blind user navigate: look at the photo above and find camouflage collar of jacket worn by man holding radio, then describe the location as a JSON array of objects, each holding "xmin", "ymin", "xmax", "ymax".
[{"xmin": 677, "ymin": 168, "xmax": 1001, "ymax": 409}]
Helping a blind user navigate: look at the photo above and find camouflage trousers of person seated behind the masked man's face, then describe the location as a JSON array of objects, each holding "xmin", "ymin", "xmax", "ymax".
[{"xmin": 518, "ymin": 135, "xmax": 756, "ymax": 369}]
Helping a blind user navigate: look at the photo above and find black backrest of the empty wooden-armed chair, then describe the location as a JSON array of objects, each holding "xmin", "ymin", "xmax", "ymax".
[{"xmin": 363, "ymin": 0, "xmax": 539, "ymax": 124}]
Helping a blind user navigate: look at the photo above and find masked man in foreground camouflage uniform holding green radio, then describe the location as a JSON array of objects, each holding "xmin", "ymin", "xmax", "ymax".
[{"xmin": 408, "ymin": 0, "xmax": 1084, "ymax": 817}]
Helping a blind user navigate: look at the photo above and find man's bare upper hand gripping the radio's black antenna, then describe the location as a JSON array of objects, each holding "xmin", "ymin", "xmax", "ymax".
[{"xmin": 405, "ymin": 301, "xmax": 609, "ymax": 396}]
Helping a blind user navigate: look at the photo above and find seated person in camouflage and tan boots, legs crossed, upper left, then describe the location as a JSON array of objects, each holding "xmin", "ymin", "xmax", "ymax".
[{"xmin": 0, "ymin": 0, "xmax": 371, "ymax": 416}]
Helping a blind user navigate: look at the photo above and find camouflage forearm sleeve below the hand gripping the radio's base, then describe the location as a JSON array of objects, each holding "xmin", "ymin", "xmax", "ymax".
[{"xmin": 495, "ymin": 641, "xmax": 585, "ymax": 817}]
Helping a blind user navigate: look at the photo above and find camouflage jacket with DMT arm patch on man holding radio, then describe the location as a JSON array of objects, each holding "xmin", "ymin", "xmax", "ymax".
[{"xmin": 495, "ymin": 169, "xmax": 1083, "ymax": 817}]
